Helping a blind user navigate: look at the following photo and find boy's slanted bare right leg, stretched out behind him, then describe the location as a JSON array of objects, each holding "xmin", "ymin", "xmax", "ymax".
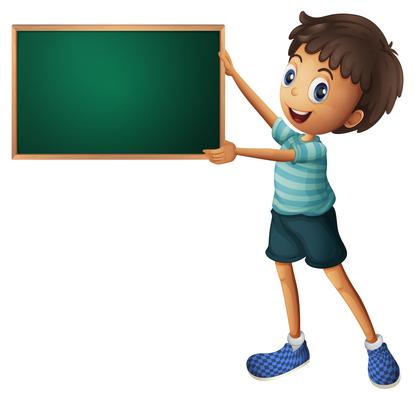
[{"xmin": 324, "ymin": 264, "xmax": 377, "ymax": 343}]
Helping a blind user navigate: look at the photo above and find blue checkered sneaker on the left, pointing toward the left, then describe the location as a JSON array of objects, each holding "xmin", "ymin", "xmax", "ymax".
[{"xmin": 246, "ymin": 340, "xmax": 310, "ymax": 379}]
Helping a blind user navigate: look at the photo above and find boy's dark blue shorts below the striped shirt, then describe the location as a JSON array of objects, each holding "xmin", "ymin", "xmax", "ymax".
[{"xmin": 265, "ymin": 207, "xmax": 347, "ymax": 268}]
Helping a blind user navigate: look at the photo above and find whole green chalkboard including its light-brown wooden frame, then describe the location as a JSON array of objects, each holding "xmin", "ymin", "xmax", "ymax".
[{"xmin": 13, "ymin": 25, "xmax": 224, "ymax": 158}]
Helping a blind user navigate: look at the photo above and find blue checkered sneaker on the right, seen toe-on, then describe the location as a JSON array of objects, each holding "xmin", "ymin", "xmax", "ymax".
[{"xmin": 367, "ymin": 343, "xmax": 400, "ymax": 387}]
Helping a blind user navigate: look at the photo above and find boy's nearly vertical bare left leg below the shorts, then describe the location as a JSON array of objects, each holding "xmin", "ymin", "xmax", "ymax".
[{"xmin": 275, "ymin": 261, "xmax": 301, "ymax": 338}]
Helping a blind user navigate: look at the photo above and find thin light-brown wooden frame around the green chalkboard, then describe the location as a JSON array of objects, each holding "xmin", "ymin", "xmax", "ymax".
[{"xmin": 12, "ymin": 25, "xmax": 225, "ymax": 160}]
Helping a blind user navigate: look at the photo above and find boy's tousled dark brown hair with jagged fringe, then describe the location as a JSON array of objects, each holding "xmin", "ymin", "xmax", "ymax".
[{"xmin": 288, "ymin": 11, "xmax": 403, "ymax": 133}]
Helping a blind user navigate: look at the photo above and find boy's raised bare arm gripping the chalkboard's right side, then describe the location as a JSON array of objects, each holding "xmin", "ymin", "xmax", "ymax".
[{"xmin": 223, "ymin": 50, "xmax": 277, "ymax": 127}]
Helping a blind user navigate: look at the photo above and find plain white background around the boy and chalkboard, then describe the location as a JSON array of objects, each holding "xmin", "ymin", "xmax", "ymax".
[{"xmin": 0, "ymin": 0, "xmax": 415, "ymax": 400}]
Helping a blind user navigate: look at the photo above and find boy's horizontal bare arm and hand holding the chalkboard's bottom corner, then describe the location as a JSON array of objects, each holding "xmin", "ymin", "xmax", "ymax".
[{"xmin": 203, "ymin": 141, "xmax": 295, "ymax": 164}]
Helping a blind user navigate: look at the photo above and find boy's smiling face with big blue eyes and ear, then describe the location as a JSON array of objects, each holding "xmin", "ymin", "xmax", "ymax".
[{"xmin": 280, "ymin": 44, "xmax": 363, "ymax": 135}]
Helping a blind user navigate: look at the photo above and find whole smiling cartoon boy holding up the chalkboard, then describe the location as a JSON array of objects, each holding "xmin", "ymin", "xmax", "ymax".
[{"xmin": 204, "ymin": 12, "xmax": 403, "ymax": 387}]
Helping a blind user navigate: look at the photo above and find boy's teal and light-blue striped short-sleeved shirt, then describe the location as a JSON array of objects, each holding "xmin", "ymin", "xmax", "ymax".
[{"xmin": 272, "ymin": 118, "xmax": 336, "ymax": 216}]
